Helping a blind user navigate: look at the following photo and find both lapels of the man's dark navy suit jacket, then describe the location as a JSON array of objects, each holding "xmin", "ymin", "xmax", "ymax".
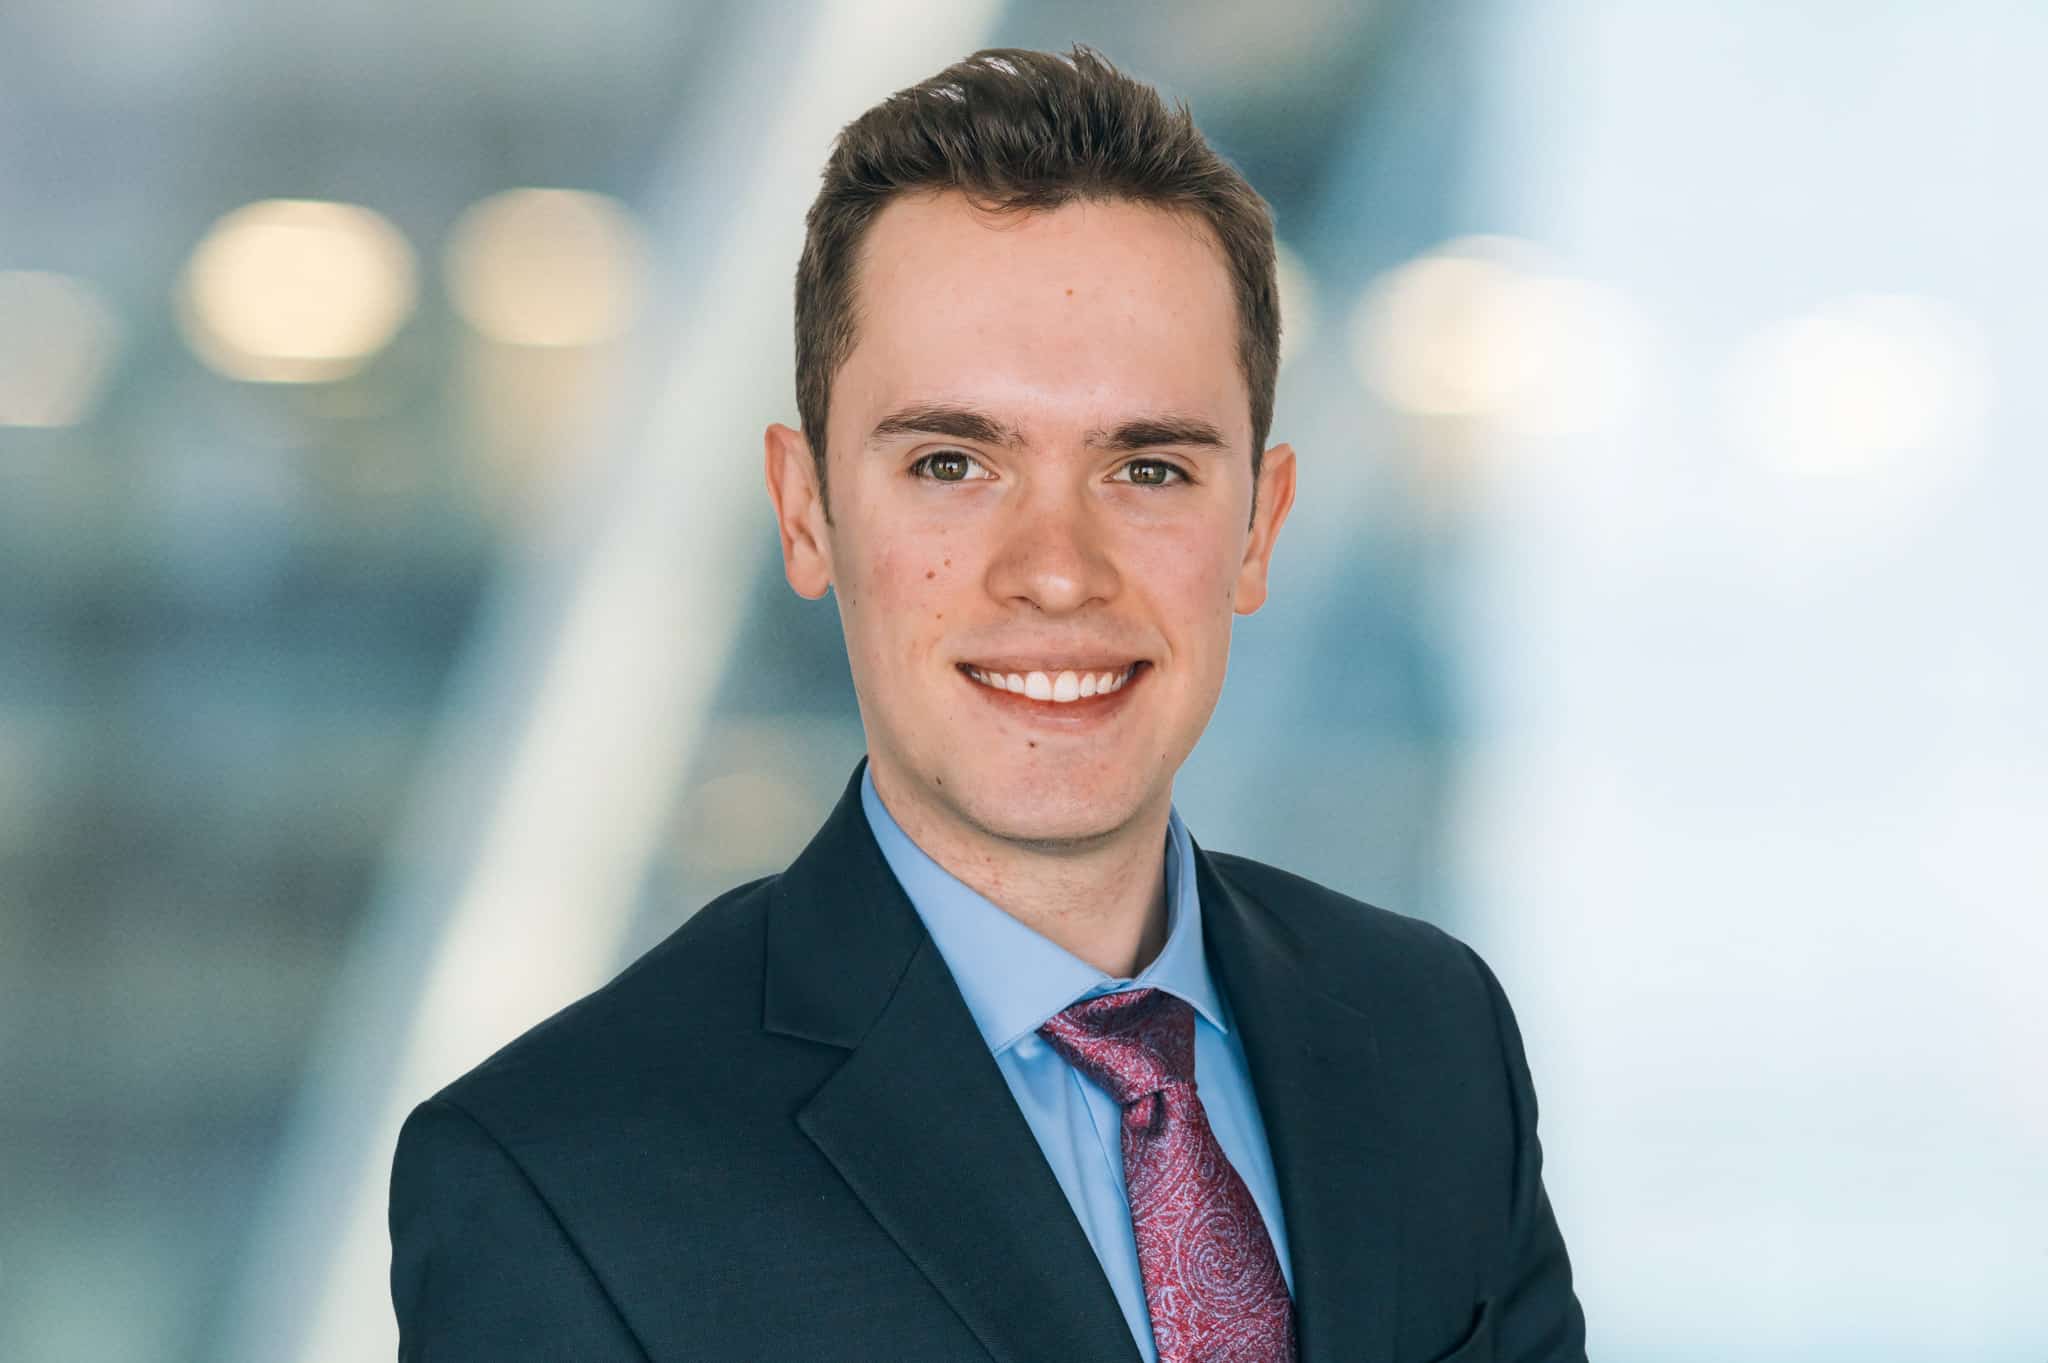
[{"xmin": 762, "ymin": 763, "xmax": 1397, "ymax": 1363}]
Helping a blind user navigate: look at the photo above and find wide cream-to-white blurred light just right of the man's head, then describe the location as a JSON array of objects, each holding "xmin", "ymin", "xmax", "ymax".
[{"xmin": 1352, "ymin": 237, "xmax": 1642, "ymax": 436}]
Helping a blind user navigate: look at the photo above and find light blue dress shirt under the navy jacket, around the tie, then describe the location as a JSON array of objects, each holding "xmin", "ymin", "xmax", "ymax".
[{"xmin": 860, "ymin": 772, "xmax": 1294, "ymax": 1363}]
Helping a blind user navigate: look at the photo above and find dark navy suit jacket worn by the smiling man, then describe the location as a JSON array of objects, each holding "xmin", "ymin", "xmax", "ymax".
[{"xmin": 391, "ymin": 770, "xmax": 1585, "ymax": 1363}]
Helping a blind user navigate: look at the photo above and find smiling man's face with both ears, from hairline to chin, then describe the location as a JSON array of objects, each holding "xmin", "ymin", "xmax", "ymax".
[{"xmin": 768, "ymin": 192, "xmax": 1294, "ymax": 849}]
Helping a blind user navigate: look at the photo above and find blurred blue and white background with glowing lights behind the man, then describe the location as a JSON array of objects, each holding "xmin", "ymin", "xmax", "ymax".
[{"xmin": 0, "ymin": 0, "xmax": 2048, "ymax": 1363}]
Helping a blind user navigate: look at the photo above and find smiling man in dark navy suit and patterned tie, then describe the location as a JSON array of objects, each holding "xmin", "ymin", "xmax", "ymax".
[{"xmin": 391, "ymin": 49, "xmax": 1583, "ymax": 1363}]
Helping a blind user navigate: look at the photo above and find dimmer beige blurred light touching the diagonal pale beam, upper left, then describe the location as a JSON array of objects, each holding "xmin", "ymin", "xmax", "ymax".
[{"xmin": 444, "ymin": 188, "xmax": 645, "ymax": 346}]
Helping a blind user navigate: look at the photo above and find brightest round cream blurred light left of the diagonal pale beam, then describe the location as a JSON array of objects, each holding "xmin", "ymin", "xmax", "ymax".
[{"xmin": 178, "ymin": 199, "xmax": 418, "ymax": 383}]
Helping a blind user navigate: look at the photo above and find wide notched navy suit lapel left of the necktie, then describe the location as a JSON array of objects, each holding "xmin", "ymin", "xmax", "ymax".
[{"xmin": 764, "ymin": 767, "xmax": 1137, "ymax": 1363}]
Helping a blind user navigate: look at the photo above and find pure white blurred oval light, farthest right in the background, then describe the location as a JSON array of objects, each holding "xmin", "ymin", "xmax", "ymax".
[{"xmin": 1722, "ymin": 295, "xmax": 1989, "ymax": 477}]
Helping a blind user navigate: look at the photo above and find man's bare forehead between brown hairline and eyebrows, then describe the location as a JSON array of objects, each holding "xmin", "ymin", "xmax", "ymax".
[{"xmin": 831, "ymin": 192, "xmax": 1251, "ymax": 446}]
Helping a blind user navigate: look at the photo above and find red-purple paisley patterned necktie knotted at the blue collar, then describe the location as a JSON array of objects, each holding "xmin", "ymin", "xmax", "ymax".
[{"xmin": 1038, "ymin": 988, "xmax": 1294, "ymax": 1363}]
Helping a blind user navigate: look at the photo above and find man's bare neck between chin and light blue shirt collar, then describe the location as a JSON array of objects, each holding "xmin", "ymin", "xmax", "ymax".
[{"xmin": 868, "ymin": 761, "xmax": 1171, "ymax": 978}]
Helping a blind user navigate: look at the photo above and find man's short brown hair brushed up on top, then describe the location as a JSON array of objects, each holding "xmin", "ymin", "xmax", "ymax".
[{"xmin": 797, "ymin": 45, "xmax": 1280, "ymax": 518}]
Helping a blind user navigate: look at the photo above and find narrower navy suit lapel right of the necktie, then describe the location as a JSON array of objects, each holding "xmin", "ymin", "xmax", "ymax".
[{"xmin": 1194, "ymin": 847, "xmax": 1399, "ymax": 1363}]
